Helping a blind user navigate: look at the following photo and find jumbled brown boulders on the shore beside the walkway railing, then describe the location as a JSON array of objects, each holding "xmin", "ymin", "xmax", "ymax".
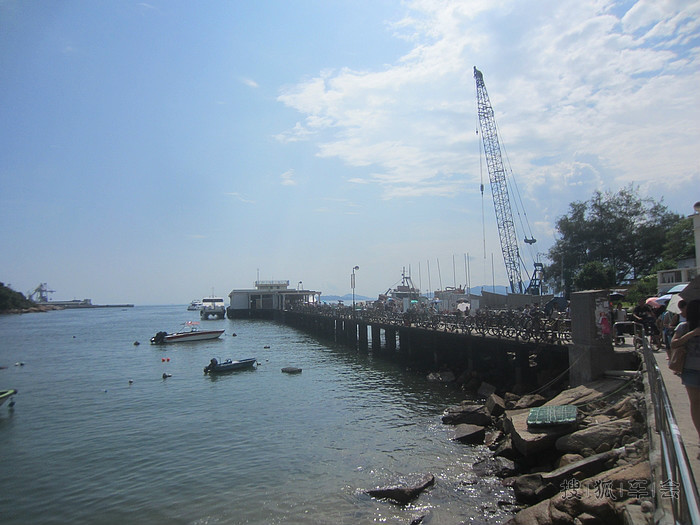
[{"xmin": 368, "ymin": 378, "xmax": 655, "ymax": 525}]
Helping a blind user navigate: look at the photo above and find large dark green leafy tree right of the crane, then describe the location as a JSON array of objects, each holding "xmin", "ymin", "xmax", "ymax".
[{"xmin": 545, "ymin": 185, "xmax": 694, "ymax": 295}]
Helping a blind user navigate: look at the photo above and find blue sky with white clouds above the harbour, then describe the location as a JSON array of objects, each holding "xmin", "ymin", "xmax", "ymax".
[{"xmin": 0, "ymin": 0, "xmax": 700, "ymax": 304}]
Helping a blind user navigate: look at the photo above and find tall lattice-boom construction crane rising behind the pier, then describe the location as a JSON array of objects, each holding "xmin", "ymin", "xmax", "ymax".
[{"xmin": 474, "ymin": 66, "xmax": 544, "ymax": 295}]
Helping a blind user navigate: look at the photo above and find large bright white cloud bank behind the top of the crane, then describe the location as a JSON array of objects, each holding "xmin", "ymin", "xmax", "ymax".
[{"xmin": 279, "ymin": 0, "xmax": 700, "ymax": 218}]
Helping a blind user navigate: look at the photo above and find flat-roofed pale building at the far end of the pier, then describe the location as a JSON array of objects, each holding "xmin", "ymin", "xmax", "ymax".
[{"xmin": 226, "ymin": 281, "xmax": 321, "ymax": 319}]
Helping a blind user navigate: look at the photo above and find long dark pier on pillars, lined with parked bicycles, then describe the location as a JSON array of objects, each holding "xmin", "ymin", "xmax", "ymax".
[{"xmin": 276, "ymin": 306, "xmax": 569, "ymax": 391}]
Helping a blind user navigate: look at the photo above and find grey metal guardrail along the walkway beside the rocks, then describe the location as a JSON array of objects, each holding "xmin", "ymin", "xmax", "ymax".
[{"xmin": 642, "ymin": 330, "xmax": 700, "ymax": 525}]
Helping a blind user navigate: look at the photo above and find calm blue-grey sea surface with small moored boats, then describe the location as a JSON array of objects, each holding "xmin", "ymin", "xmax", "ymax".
[{"xmin": 0, "ymin": 306, "xmax": 512, "ymax": 525}]
